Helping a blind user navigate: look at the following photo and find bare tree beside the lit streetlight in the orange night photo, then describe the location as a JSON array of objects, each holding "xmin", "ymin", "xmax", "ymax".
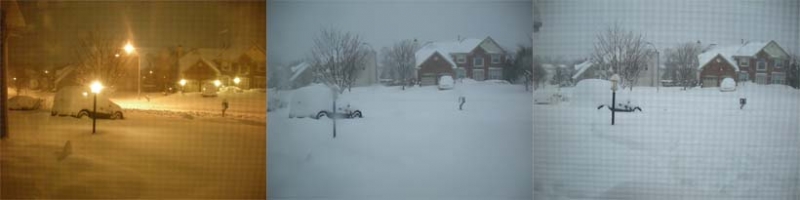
[{"xmin": 74, "ymin": 31, "xmax": 138, "ymax": 88}]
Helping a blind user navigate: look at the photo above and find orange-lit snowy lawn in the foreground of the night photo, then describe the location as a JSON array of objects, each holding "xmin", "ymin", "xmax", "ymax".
[{"xmin": 0, "ymin": 101, "xmax": 267, "ymax": 199}]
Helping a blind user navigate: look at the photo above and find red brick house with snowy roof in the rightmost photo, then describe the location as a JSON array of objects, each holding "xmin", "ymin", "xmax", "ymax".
[{"xmin": 697, "ymin": 41, "xmax": 789, "ymax": 87}]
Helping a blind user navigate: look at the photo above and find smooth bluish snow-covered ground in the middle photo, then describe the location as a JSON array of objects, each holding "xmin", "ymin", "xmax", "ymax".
[{"xmin": 267, "ymin": 80, "xmax": 533, "ymax": 199}]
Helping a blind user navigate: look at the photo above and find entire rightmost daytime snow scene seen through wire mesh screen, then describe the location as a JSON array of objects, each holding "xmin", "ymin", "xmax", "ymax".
[{"xmin": 533, "ymin": 0, "xmax": 800, "ymax": 199}]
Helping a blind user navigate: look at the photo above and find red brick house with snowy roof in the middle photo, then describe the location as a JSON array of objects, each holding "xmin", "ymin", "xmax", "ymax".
[{"xmin": 415, "ymin": 37, "xmax": 510, "ymax": 85}]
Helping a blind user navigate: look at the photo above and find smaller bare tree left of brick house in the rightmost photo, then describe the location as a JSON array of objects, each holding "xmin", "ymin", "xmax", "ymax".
[{"xmin": 665, "ymin": 42, "xmax": 703, "ymax": 89}]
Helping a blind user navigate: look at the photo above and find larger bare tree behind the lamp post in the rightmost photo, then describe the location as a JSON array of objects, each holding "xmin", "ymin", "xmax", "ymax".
[{"xmin": 591, "ymin": 24, "xmax": 651, "ymax": 90}]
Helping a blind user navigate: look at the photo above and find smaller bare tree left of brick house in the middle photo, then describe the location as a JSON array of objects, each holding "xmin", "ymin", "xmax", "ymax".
[{"xmin": 383, "ymin": 40, "xmax": 419, "ymax": 90}]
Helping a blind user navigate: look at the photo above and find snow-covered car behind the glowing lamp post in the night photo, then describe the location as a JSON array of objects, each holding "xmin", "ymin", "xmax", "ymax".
[{"xmin": 50, "ymin": 86, "xmax": 124, "ymax": 119}]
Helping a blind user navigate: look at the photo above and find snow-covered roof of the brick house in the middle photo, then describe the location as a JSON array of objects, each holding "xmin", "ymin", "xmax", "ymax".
[{"xmin": 414, "ymin": 37, "xmax": 489, "ymax": 69}]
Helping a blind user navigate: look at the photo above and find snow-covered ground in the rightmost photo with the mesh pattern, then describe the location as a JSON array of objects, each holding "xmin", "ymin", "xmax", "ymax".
[{"xmin": 533, "ymin": 80, "xmax": 800, "ymax": 200}]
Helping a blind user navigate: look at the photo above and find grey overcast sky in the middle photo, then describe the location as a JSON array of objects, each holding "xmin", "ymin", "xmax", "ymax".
[{"xmin": 267, "ymin": 0, "xmax": 533, "ymax": 64}]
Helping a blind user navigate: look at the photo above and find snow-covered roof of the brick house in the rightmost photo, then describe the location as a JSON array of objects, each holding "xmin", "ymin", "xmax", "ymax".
[{"xmin": 697, "ymin": 41, "xmax": 782, "ymax": 71}]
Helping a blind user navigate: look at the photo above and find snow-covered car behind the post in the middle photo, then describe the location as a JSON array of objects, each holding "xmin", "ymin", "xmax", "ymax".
[{"xmin": 289, "ymin": 84, "xmax": 363, "ymax": 119}]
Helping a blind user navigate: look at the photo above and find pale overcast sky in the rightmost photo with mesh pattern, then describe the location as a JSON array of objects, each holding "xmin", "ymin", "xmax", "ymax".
[{"xmin": 534, "ymin": 0, "xmax": 800, "ymax": 59}]
